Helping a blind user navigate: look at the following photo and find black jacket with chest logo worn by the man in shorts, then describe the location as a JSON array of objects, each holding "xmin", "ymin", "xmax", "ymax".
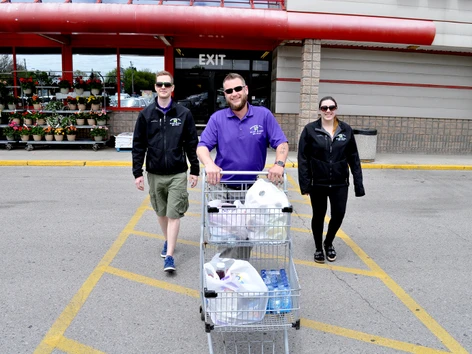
[{"xmin": 133, "ymin": 101, "xmax": 200, "ymax": 178}]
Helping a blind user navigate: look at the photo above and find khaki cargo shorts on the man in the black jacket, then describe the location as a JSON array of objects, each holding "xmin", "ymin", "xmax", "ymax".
[{"xmin": 147, "ymin": 172, "xmax": 189, "ymax": 219}]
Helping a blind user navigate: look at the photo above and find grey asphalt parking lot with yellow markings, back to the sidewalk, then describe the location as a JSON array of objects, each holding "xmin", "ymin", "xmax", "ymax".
[{"xmin": 0, "ymin": 149, "xmax": 472, "ymax": 354}]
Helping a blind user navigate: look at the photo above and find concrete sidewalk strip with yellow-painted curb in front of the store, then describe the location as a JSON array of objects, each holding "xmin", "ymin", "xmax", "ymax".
[{"xmin": 0, "ymin": 146, "xmax": 472, "ymax": 170}]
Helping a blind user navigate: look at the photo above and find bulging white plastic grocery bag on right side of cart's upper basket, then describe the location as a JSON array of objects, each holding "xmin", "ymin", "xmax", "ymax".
[{"xmin": 245, "ymin": 179, "xmax": 290, "ymax": 240}]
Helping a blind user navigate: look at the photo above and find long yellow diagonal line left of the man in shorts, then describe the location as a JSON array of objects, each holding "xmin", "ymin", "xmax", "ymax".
[{"xmin": 34, "ymin": 196, "xmax": 149, "ymax": 354}]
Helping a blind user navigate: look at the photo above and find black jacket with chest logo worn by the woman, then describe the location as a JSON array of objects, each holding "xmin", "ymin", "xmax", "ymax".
[{"xmin": 298, "ymin": 119, "xmax": 365, "ymax": 197}]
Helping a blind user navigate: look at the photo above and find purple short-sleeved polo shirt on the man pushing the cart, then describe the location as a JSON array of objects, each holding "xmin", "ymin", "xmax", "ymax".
[{"xmin": 198, "ymin": 104, "xmax": 288, "ymax": 181}]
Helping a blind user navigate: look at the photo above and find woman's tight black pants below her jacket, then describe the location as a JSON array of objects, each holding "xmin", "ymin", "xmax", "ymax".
[{"xmin": 310, "ymin": 186, "xmax": 349, "ymax": 250}]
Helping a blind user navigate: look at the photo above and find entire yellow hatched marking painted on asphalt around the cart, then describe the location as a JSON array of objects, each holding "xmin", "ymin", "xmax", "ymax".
[{"xmin": 35, "ymin": 176, "xmax": 467, "ymax": 354}]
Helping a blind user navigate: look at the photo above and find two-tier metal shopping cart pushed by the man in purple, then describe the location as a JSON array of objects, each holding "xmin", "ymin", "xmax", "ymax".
[{"xmin": 200, "ymin": 171, "xmax": 300, "ymax": 354}]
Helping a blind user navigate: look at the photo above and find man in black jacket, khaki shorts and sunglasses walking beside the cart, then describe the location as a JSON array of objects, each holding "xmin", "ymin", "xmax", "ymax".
[{"xmin": 133, "ymin": 71, "xmax": 200, "ymax": 272}]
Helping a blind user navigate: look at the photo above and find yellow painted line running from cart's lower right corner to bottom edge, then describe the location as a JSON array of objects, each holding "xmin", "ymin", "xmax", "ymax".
[{"xmin": 300, "ymin": 318, "xmax": 450, "ymax": 354}]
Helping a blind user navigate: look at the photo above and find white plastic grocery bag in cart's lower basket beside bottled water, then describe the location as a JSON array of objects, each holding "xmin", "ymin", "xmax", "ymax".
[{"xmin": 204, "ymin": 258, "xmax": 268, "ymax": 326}]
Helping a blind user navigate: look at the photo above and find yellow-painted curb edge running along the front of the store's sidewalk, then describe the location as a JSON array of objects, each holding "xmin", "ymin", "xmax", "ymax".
[{"xmin": 0, "ymin": 160, "xmax": 472, "ymax": 171}]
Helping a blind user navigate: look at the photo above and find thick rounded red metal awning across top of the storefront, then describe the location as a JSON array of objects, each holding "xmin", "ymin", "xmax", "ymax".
[{"xmin": 0, "ymin": 3, "xmax": 436, "ymax": 45}]
